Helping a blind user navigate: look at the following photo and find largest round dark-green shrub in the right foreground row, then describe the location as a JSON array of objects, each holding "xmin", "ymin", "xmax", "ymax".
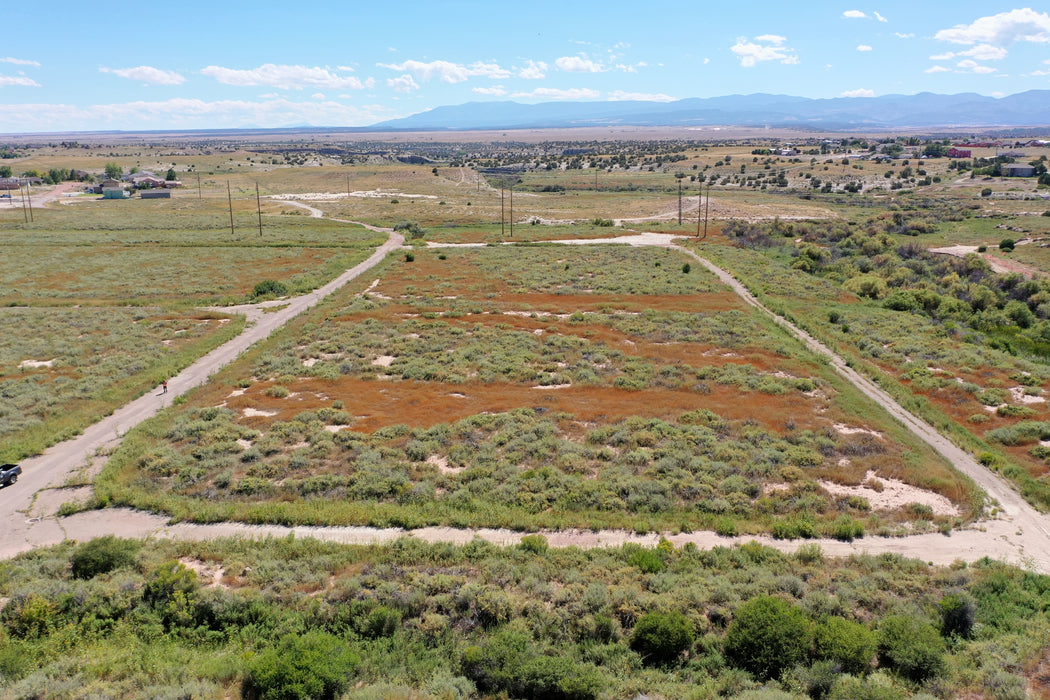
[{"xmin": 725, "ymin": 596, "xmax": 811, "ymax": 680}]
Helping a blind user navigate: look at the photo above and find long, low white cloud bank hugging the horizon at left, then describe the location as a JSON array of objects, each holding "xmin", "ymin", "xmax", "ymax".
[{"xmin": 0, "ymin": 99, "xmax": 394, "ymax": 132}]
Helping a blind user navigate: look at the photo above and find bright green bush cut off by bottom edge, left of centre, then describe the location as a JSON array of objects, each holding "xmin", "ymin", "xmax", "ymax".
[{"xmin": 240, "ymin": 632, "xmax": 360, "ymax": 700}]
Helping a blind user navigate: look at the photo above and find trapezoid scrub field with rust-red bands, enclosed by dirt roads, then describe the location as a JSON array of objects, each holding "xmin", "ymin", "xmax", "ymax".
[{"xmin": 92, "ymin": 247, "xmax": 977, "ymax": 537}]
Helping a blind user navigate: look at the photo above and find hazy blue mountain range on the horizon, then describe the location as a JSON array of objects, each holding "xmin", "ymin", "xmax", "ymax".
[{"xmin": 369, "ymin": 90, "xmax": 1050, "ymax": 131}]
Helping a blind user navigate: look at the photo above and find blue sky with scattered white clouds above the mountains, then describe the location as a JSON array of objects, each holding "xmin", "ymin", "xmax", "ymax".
[{"xmin": 0, "ymin": 0, "xmax": 1050, "ymax": 134}]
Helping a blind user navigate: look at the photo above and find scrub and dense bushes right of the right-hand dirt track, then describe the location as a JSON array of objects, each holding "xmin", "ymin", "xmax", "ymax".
[{"xmin": 705, "ymin": 210, "xmax": 1050, "ymax": 508}]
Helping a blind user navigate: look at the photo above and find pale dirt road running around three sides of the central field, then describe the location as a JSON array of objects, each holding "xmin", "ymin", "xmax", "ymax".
[{"xmin": 8, "ymin": 227, "xmax": 1050, "ymax": 573}]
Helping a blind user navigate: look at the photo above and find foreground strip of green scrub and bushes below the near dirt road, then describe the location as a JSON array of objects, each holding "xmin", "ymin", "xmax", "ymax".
[{"xmin": 0, "ymin": 535, "xmax": 1050, "ymax": 700}]
